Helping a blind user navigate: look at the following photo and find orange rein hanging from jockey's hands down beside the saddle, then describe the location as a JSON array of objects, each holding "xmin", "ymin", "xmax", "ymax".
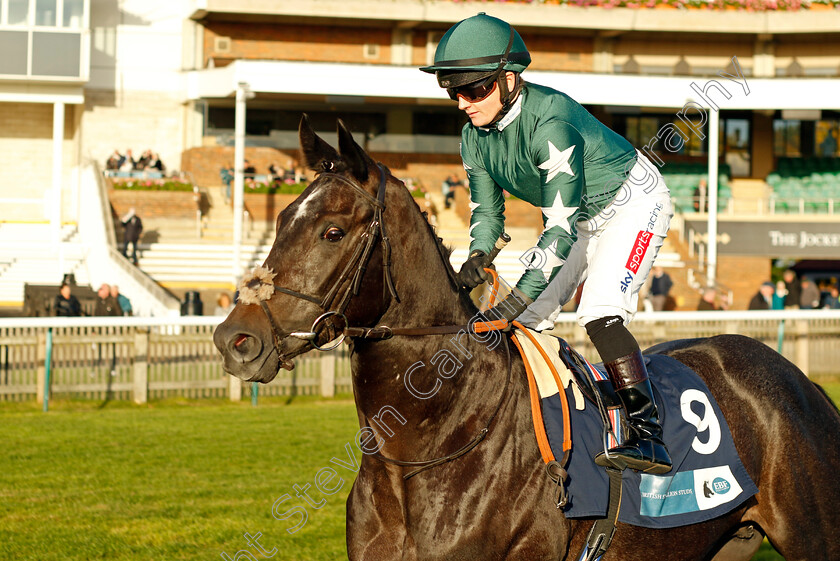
[{"xmin": 475, "ymin": 269, "xmax": 572, "ymax": 463}]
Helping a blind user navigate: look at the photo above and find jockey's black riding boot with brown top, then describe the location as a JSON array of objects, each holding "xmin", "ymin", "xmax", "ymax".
[{"xmin": 595, "ymin": 351, "xmax": 671, "ymax": 475}]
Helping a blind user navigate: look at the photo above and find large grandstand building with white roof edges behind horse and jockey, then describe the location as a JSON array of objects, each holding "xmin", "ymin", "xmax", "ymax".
[{"xmin": 0, "ymin": 0, "xmax": 840, "ymax": 313}]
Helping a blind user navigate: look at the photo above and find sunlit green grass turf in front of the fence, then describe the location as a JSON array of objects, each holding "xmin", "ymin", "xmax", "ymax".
[{"xmin": 0, "ymin": 383, "xmax": 840, "ymax": 561}]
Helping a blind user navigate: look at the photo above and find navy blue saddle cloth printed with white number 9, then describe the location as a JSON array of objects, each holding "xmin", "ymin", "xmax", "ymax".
[{"xmin": 542, "ymin": 355, "xmax": 758, "ymax": 528}]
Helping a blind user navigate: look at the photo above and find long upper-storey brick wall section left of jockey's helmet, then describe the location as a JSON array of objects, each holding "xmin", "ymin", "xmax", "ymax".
[{"xmin": 204, "ymin": 22, "xmax": 391, "ymax": 64}]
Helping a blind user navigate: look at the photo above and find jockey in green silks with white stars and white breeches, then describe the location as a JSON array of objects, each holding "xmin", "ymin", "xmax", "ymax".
[{"xmin": 421, "ymin": 13, "xmax": 673, "ymax": 474}]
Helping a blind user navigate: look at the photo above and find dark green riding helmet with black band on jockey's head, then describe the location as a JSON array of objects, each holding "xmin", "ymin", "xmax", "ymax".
[{"xmin": 420, "ymin": 12, "xmax": 531, "ymax": 88}]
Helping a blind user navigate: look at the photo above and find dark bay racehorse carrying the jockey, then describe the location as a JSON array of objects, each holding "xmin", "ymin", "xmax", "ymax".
[{"xmin": 214, "ymin": 118, "xmax": 840, "ymax": 561}]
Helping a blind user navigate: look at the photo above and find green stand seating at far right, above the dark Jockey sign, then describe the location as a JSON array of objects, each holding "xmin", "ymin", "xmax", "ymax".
[{"xmin": 766, "ymin": 157, "xmax": 840, "ymax": 214}]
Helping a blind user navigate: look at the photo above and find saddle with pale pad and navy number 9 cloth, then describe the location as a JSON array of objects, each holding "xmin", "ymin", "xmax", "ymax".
[{"xmin": 513, "ymin": 326, "xmax": 758, "ymax": 528}]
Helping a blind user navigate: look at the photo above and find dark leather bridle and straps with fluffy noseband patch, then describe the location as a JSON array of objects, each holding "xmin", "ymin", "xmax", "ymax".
[{"xmin": 240, "ymin": 163, "xmax": 513, "ymax": 480}]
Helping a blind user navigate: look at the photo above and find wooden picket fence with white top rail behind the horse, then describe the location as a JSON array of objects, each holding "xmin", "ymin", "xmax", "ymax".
[{"xmin": 0, "ymin": 310, "xmax": 840, "ymax": 403}]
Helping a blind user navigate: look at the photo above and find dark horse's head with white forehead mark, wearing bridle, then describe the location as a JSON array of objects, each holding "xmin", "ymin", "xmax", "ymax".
[{"xmin": 213, "ymin": 116, "xmax": 451, "ymax": 382}]
